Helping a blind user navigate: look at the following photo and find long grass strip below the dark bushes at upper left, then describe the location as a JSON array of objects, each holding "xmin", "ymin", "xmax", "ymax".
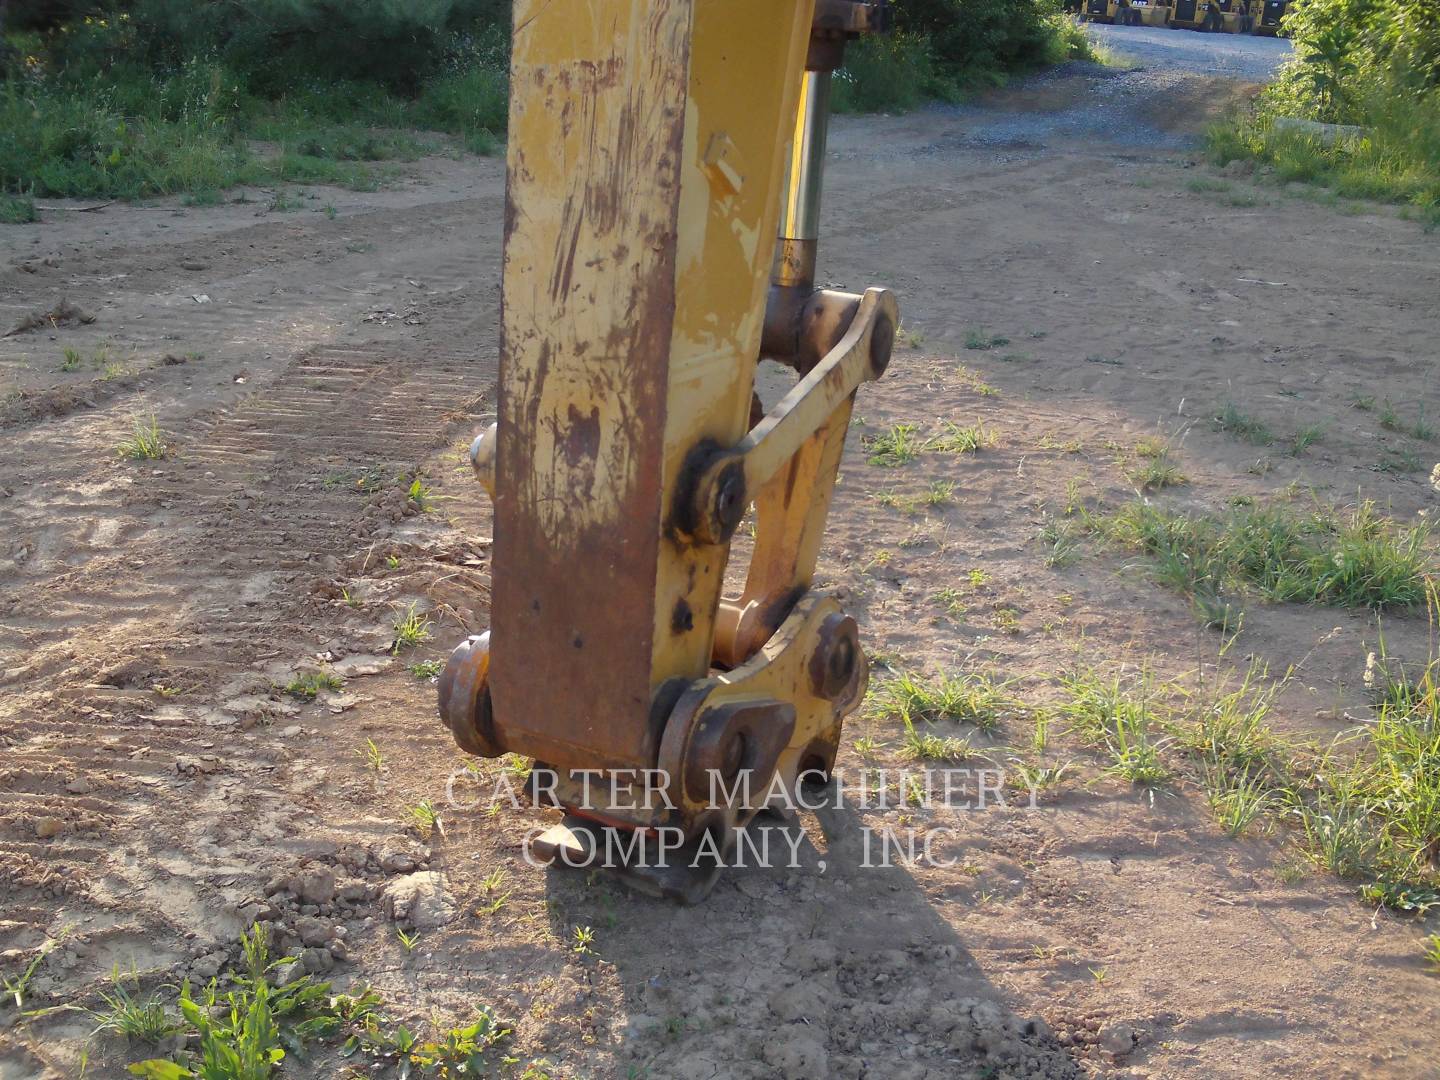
[{"xmin": 0, "ymin": 58, "xmax": 505, "ymax": 203}]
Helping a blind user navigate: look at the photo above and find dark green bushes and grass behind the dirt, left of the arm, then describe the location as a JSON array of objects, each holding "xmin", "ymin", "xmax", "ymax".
[{"xmin": 0, "ymin": 0, "xmax": 508, "ymax": 201}]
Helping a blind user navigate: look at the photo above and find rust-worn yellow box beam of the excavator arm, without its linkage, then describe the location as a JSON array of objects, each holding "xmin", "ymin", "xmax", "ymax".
[{"xmin": 490, "ymin": 0, "xmax": 814, "ymax": 768}]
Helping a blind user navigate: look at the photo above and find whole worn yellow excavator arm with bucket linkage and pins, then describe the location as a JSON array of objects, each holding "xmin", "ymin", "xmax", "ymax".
[{"xmin": 439, "ymin": 0, "xmax": 899, "ymax": 901}]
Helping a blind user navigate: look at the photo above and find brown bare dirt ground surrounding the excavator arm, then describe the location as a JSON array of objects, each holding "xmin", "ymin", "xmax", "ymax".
[{"xmin": 0, "ymin": 36, "xmax": 1440, "ymax": 1080}]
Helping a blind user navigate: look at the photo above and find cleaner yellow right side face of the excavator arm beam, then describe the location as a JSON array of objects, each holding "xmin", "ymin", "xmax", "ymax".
[{"xmin": 654, "ymin": 0, "xmax": 814, "ymax": 683}]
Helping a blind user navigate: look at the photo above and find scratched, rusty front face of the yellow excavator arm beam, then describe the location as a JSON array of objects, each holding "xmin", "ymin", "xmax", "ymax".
[{"xmin": 491, "ymin": 0, "xmax": 691, "ymax": 768}]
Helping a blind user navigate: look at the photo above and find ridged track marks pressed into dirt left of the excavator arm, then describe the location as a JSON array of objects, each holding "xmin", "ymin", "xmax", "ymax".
[{"xmin": 0, "ymin": 336, "xmax": 494, "ymax": 1025}]
